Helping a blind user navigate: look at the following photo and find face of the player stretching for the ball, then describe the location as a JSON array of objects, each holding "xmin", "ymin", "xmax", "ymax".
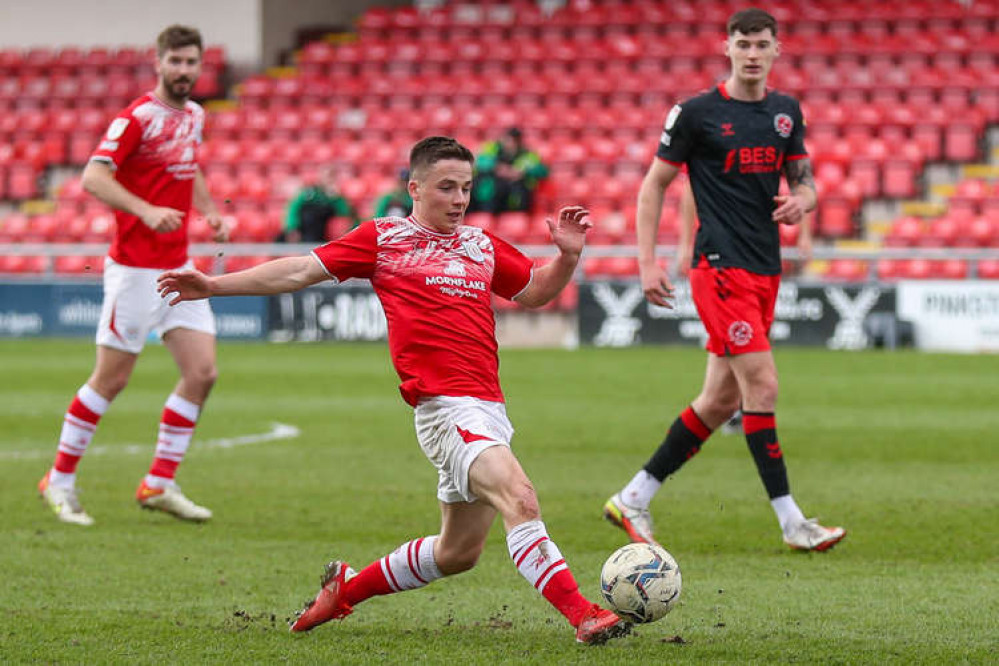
[{"xmin": 409, "ymin": 160, "xmax": 472, "ymax": 234}]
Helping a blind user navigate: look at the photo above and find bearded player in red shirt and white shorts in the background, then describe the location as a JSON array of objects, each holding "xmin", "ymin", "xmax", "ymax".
[{"xmin": 38, "ymin": 25, "xmax": 228, "ymax": 525}]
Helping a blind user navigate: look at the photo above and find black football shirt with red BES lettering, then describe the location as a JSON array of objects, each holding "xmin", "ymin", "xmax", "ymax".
[{"xmin": 656, "ymin": 84, "xmax": 808, "ymax": 275}]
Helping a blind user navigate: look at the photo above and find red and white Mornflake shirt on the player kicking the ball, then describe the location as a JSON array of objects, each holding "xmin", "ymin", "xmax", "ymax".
[{"xmin": 313, "ymin": 217, "xmax": 532, "ymax": 406}]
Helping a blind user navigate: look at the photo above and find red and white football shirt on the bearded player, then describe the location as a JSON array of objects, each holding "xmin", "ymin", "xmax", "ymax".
[{"xmin": 90, "ymin": 93, "xmax": 205, "ymax": 268}]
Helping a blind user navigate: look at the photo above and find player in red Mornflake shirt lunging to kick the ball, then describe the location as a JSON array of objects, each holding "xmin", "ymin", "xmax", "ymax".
[{"xmin": 160, "ymin": 137, "xmax": 629, "ymax": 644}]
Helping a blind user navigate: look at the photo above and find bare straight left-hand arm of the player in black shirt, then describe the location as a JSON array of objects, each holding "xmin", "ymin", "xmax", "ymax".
[{"xmin": 635, "ymin": 159, "xmax": 680, "ymax": 308}]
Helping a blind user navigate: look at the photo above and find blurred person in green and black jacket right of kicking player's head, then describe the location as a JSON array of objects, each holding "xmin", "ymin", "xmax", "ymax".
[{"xmin": 470, "ymin": 127, "xmax": 548, "ymax": 213}]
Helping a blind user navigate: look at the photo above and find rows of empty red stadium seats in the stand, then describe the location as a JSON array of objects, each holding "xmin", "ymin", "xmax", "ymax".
[{"xmin": 0, "ymin": 0, "xmax": 999, "ymax": 279}]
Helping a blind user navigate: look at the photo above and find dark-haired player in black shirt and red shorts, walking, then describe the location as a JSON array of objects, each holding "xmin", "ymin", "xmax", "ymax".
[{"xmin": 604, "ymin": 9, "xmax": 846, "ymax": 550}]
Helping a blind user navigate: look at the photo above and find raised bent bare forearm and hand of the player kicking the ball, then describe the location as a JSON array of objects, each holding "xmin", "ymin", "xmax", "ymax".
[{"xmin": 517, "ymin": 206, "xmax": 593, "ymax": 308}]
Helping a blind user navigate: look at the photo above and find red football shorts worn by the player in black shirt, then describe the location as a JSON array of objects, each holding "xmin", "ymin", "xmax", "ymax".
[{"xmin": 690, "ymin": 265, "xmax": 780, "ymax": 356}]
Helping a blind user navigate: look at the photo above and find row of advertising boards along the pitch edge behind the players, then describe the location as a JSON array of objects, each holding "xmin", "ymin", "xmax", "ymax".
[{"xmin": 7, "ymin": 280, "xmax": 999, "ymax": 353}]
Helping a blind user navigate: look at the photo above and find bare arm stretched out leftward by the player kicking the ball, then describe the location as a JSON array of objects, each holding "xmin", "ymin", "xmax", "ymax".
[{"xmin": 156, "ymin": 255, "xmax": 329, "ymax": 305}]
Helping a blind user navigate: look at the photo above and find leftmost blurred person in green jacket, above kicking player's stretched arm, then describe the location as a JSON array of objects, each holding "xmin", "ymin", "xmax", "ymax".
[{"xmin": 277, "ymin": 165, "xmax": 358, "ymax": 243}]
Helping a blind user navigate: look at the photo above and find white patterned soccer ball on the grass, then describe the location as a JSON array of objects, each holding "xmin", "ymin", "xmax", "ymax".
[{"xmin": 600, "ymin": 543, "xmax": 682, "ymax": 622}]
